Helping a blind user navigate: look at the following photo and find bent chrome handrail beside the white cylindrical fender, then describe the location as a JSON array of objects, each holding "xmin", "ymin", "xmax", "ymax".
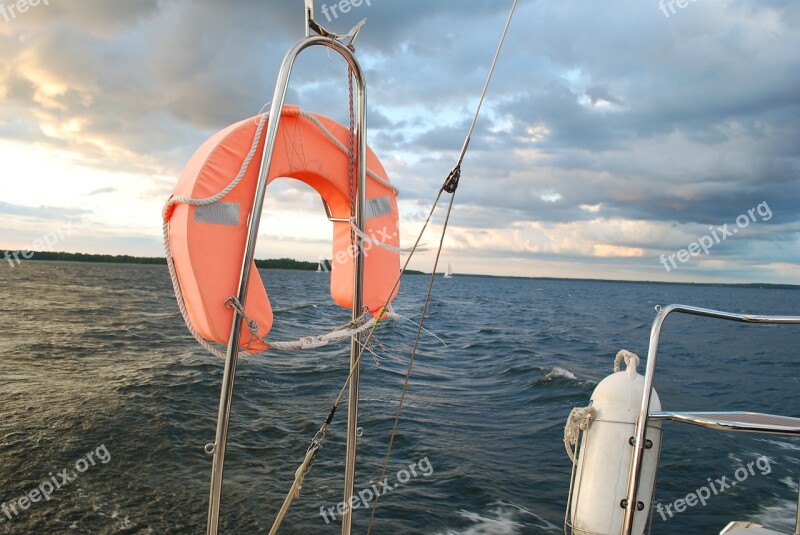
[{"xmin": 621, "ymin": 305, "xmax": 800, "ymax": 535}]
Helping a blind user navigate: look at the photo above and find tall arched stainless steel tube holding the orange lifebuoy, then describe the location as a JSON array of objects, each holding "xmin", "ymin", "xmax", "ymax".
[{"xmin": 206, "ymin": 36, "xmax": 367, "ymax": 535}]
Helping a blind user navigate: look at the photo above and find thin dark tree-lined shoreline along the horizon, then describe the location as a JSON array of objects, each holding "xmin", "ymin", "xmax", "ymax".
[{"xmin": 0, "ymin": 249, "xmax": 800, "ymax": 290}]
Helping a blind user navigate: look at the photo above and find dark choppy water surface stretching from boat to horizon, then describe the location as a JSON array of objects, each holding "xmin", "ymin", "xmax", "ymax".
[{"xmin": 0, "ymin": 262, "xmax": 800, "ymax": 535}]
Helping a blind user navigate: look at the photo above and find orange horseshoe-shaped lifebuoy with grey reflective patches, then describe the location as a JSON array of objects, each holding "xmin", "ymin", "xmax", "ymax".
[{"xmin": 164, "ymin": 105, "xmax": 400, "ymax": 353}]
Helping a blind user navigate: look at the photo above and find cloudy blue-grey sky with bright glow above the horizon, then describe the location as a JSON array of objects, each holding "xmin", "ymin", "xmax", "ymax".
[{"xmin": 0, "ymin": 0, "xmax": 800, "ymax": 284}]
